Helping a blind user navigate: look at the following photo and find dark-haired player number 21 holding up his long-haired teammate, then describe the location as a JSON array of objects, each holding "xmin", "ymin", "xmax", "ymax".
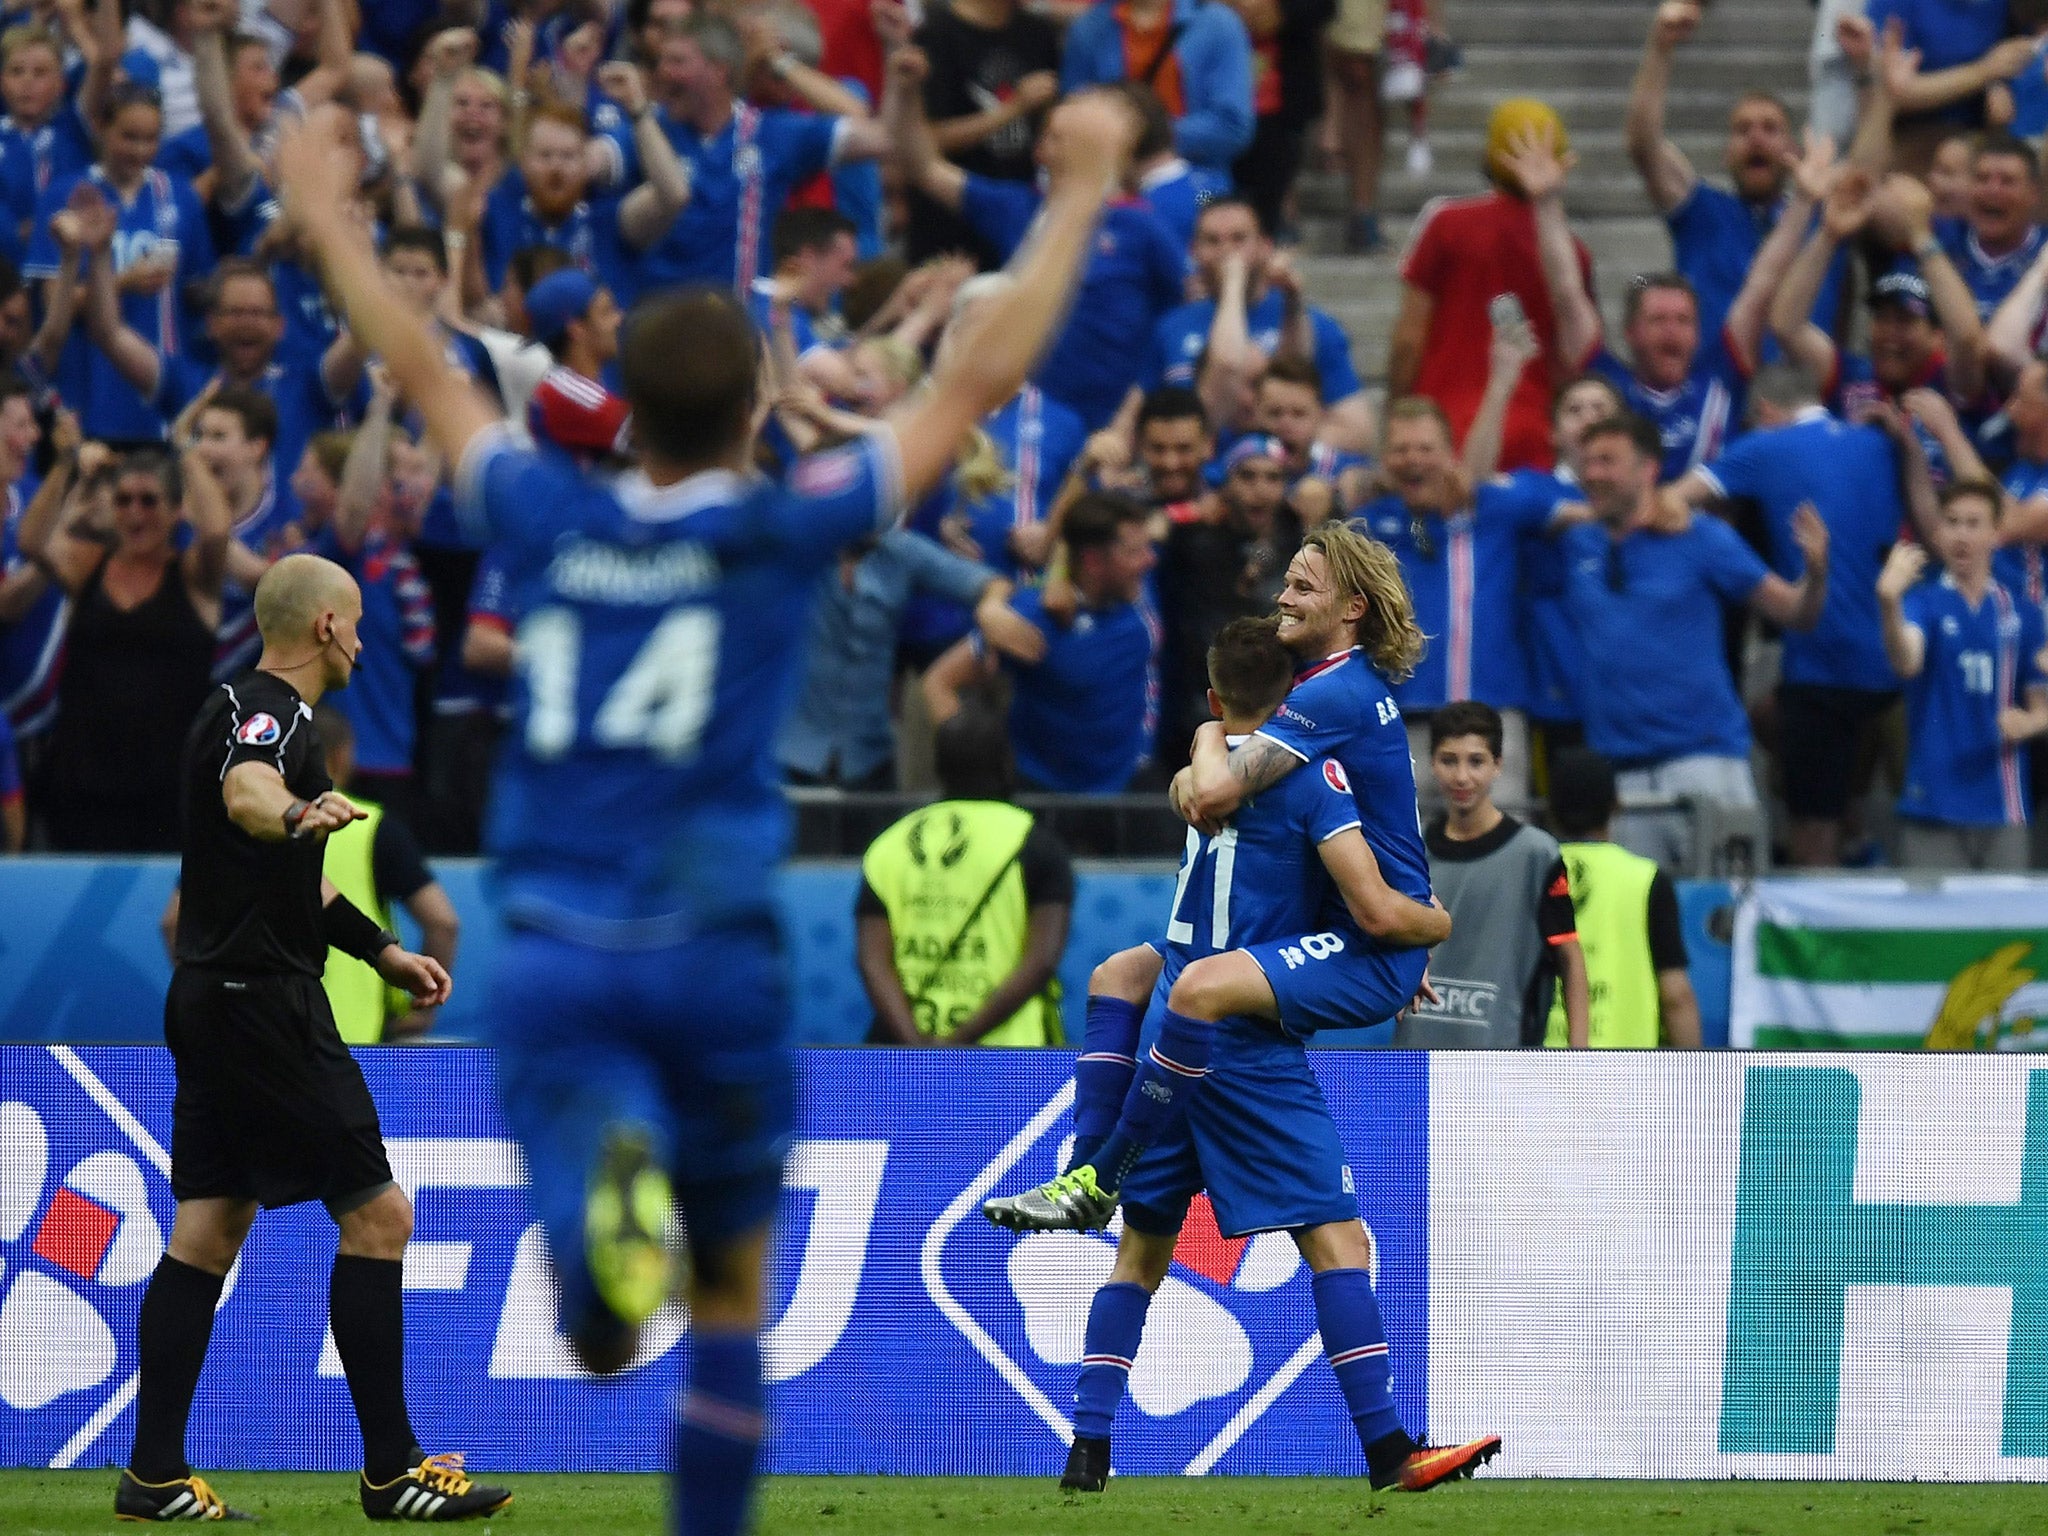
[{"xmin": 983, "ymin": 618, "xmax": 1499, "ymax": 1493}]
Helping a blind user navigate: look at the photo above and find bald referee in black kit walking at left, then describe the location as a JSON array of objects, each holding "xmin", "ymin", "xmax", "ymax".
[{"xmin": 115, "ymin": 555, "xmax": 512, "ymax": 1520}]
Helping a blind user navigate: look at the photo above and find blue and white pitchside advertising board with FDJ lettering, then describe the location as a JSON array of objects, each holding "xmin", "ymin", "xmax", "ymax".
[{"xmin": 0, "ymin": 1044, "xmax": 2048, "ymax": 1479}]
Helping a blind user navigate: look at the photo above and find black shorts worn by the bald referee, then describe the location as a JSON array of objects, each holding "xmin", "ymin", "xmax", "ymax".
[{"xmin": 164, "ymin": 965, "xmax": 391, "ymax": 1217}]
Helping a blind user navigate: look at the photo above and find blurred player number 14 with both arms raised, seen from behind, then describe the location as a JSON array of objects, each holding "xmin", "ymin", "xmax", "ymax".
[{"xmin": 281, "ymin": 92, "xmax": 1130, "ymax": 1536}]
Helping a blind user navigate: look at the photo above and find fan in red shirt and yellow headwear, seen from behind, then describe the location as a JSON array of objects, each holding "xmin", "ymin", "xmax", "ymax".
[{"xmin": 1386, "ymin": 100, "xmax": 1593, "ymax": 471}]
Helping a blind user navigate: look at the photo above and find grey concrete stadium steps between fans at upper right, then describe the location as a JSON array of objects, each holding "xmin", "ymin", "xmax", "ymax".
[{"xmin": 1300, "ymin": 0, "xmax": 1812, "ymax": 391}]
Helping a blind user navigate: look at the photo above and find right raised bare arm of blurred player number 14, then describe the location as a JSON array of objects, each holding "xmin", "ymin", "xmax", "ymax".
[{"xmin": 889, "ymin": 90, "xmax": 1135, "ymax": 504}]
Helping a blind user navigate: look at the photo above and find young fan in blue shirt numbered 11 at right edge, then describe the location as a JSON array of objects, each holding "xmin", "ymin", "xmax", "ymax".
[{"xmin": 1878, "ymin": 483, "xmax": 2048, "ymax": 868}]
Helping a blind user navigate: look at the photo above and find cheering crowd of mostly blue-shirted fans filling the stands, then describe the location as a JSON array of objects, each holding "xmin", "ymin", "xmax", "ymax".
[{"xmin": 0, "ymin": 0, "xmax": 2048, "ymax": 866}]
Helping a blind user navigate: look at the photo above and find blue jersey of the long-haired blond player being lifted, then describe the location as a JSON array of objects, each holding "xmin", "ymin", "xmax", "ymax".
[{"xmin": 1257, "ymin": 645, "xmax": 1430, "ymax": 901}]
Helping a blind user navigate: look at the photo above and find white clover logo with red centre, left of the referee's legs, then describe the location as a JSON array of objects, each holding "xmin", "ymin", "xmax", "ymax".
[{"xmin": 0, "ymin": 1044, "xmax": 174, "ymax": 1466}]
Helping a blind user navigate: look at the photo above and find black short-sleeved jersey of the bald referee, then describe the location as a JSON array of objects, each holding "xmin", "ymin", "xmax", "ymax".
[{"xmin": 176, "ymin": 672, "xmax": 334, "ymax": 977}]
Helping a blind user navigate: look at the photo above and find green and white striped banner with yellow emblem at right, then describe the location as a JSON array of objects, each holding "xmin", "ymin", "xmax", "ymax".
[{"xmin": 1729, "ymin": 874, "xmax": 2048, "ymax": 1051}]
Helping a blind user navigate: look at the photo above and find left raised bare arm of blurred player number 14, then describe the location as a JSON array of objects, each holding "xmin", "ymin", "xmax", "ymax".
[{"xmin": 276, "ymin": 106, "xmax": 500, "ymax": 475}]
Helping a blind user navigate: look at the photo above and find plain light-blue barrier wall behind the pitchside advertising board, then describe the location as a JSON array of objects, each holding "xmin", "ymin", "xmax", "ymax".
[{"xmin": 0, "ymin": 858, "xmax": 1731, "ymax": 1044}]
